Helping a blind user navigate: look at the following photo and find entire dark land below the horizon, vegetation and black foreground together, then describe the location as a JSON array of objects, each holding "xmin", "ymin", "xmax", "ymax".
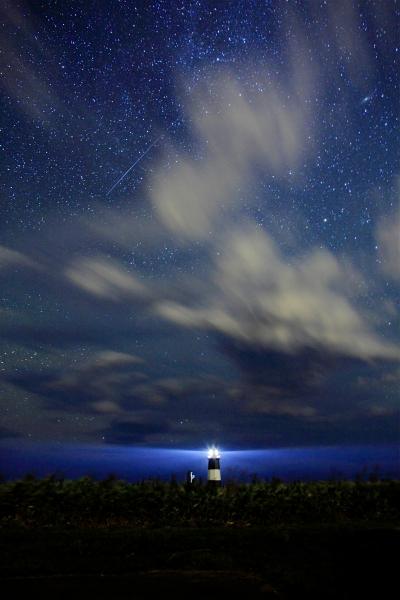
[{"xmin": 0, "ymin": 474, "xmax": 400, "ymax": 599}]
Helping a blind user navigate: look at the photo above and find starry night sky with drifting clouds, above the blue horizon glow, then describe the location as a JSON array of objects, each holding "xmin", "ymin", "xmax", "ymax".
[{"xmin": 0, "ymin": 0, "xmax": 400, "ymax": 478}]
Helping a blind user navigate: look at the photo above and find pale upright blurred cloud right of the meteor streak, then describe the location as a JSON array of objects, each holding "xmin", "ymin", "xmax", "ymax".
[{"xmin": 149, "ymin": 68, "xmax": 312, "ymax": 240}]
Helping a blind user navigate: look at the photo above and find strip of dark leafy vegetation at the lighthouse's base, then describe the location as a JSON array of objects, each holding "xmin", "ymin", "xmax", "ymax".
[{"xmin": 0, "ymin": 476, "xmax": 400, "ymax": 527}]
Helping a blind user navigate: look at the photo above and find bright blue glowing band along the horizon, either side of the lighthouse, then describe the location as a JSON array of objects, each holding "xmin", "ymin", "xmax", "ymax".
[{"xmin": 0, "ymin": 442, "xmax": 400, "ymax": 481}]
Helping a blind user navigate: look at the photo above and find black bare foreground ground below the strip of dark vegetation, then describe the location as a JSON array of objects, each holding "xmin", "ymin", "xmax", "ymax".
[{"xmin": 0, "ymin": 523, "xmax": 400, "ymax": 600}]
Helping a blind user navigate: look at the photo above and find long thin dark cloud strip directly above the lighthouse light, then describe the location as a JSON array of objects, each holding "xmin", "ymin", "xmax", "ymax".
[{"xmin": 99, "ymin": 404, "xmax": 398, "ymax": 449}]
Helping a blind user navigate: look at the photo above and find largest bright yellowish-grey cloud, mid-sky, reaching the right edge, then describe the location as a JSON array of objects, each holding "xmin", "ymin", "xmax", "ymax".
[{"xmin": 156, "ymin": 227, "xmax": 400, "ymax": 359}]
